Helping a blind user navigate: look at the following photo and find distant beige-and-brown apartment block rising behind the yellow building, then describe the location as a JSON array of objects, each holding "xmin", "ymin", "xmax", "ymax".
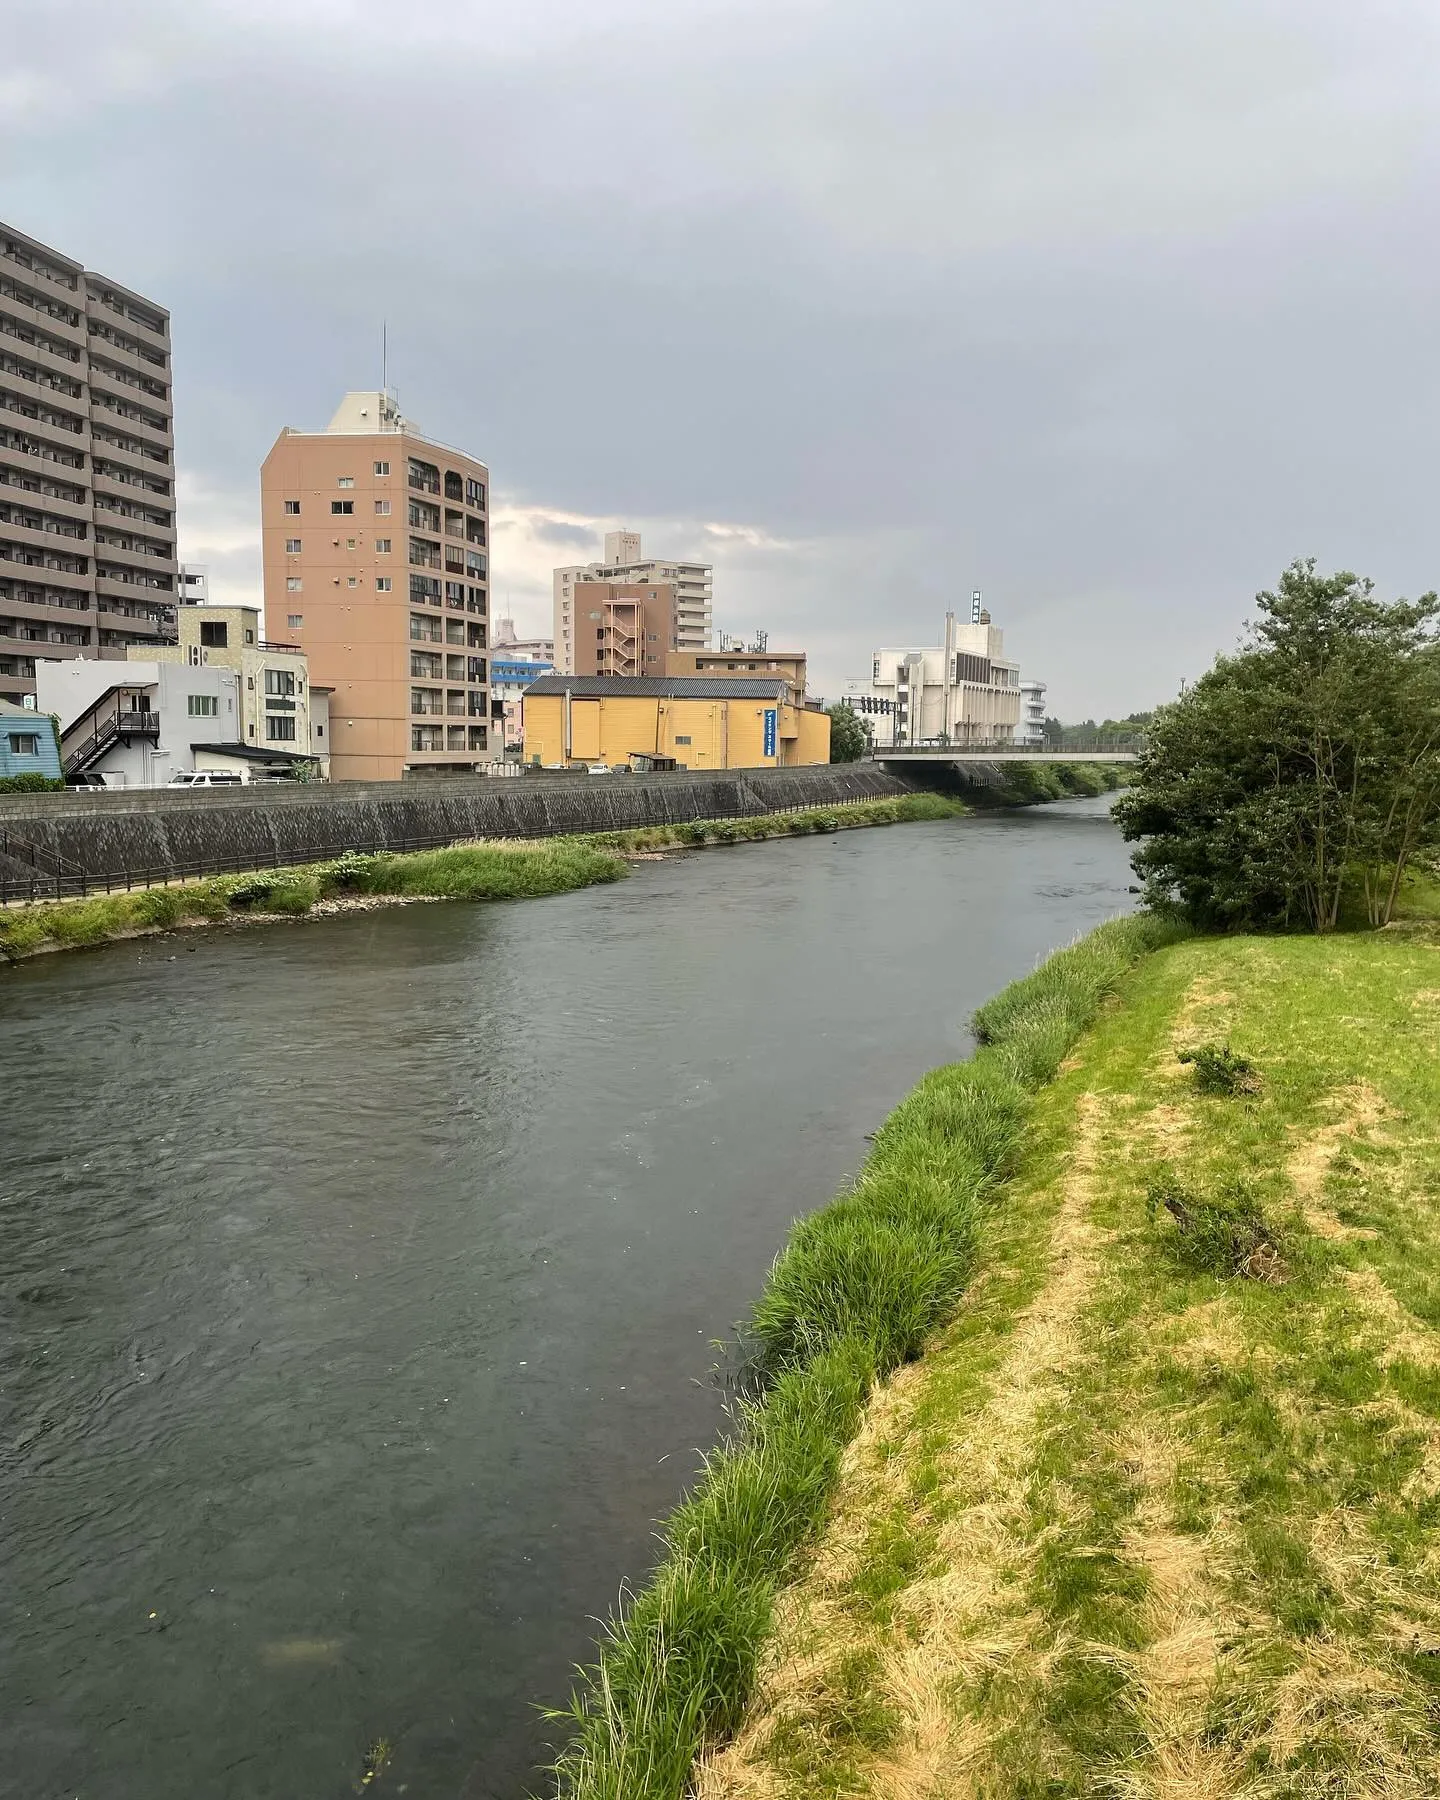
[{"xmin": 553, "ymin": 531, "xmax": 713, "ymax": 675}]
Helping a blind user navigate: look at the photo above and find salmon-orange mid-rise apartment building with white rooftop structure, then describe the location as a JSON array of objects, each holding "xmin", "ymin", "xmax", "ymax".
[{"xmin": 261, "ymin": 391, "xmax": 502, "ymax": 781}]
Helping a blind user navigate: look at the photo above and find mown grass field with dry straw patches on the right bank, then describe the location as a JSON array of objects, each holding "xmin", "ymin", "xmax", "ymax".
[{"xmin": 687, "ymin": 931, "xmax": 1440, "ymax": 1800}]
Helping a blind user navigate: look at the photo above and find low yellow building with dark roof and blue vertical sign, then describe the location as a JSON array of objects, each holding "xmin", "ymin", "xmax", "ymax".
[{"xmin": 524, "ymin": 675, "xmax": 830, "ymax": 769}]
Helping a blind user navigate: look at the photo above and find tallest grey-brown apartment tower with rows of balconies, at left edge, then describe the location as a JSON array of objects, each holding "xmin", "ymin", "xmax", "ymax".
[{"xmin": 0, "ymin": 225, "xmax": 178, "ymax": 700}]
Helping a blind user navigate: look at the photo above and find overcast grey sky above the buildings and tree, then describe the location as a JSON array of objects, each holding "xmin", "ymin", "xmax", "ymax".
[{"xmin": 0, "ymin": 0, "xmax": 1440, "ymax": 718}]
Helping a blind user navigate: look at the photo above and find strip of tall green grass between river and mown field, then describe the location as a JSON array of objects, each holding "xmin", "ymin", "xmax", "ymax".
[{"xmin": 553, "ymin": 916, "xmax": 1184, "ymax": 1800}]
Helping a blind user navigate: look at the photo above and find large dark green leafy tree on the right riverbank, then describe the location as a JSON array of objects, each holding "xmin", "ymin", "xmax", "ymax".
[{"xmin": 1114, "ymin": 560, "xmax": 1440, "ymax": 931}]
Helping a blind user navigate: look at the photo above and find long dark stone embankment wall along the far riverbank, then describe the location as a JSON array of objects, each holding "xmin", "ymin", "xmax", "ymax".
[{"xmin": 0, "ymin": 763, "xmax": 909, "ymax": 880}]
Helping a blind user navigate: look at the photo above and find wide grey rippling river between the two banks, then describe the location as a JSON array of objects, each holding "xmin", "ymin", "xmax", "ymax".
[{"xmin": 0, "ymin": 801, "xmax": 1130, "ymax": 1800}]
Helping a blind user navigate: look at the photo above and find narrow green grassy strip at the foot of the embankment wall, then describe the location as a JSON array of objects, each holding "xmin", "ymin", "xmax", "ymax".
[{"xmin": 0, "ymin": 794, "xmax": 967, "ymax": 961}]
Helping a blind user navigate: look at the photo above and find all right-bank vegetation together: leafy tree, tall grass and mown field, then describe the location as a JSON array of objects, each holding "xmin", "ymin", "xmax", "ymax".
[{"xmin": 556, "ymin": 563, "xmax": 1440, "ymax": 1800}]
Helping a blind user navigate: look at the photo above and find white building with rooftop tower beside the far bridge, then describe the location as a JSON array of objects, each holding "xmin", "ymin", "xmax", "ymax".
[{"xmin": 844, "ymin": 607, "xmax": 1021, "ymax": 749}]
